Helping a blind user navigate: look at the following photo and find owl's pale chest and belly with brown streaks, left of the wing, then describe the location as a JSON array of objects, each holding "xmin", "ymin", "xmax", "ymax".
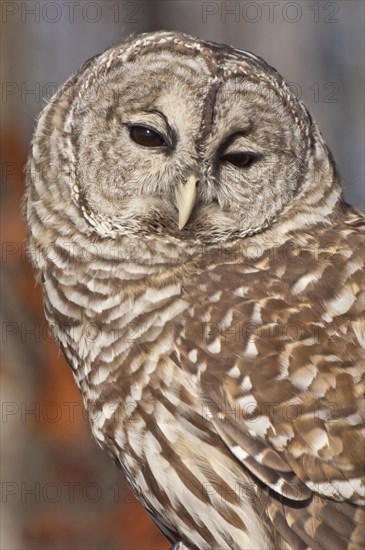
[{"xmin": 45, "ymin": 266, "xmax": 288, "ymax": 549}]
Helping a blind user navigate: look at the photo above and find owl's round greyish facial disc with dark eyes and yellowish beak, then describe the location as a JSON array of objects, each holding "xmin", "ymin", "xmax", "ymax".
[{"xmin": 72, "ymin": 34, "xmax": 307, "ymax": 244}]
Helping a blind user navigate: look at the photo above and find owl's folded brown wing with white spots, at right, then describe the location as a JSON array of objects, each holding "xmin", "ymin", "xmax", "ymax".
[{"xmin": 177, "ymin": 219, "xmax": 364, "ymax": 548}]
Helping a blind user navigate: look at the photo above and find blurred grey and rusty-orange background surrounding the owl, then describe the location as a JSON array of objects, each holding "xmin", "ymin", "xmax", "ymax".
[{"xmin": 0, "ymin": 0, "xmax": 364, "ymax": 550}]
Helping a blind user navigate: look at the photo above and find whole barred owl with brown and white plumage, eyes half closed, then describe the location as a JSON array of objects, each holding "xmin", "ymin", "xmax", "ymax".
[{"xmin": 24, "ymin": 32, "xmax": 364, "ymax": 550}]
